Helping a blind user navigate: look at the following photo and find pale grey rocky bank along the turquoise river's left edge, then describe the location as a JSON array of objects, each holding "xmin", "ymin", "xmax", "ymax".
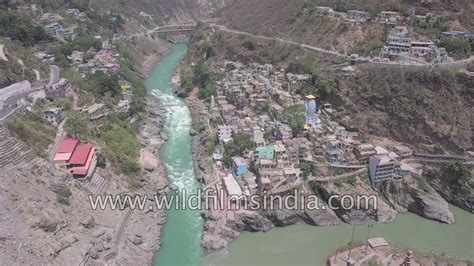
[{"xmin": 116, "ymin": 94, "xmax": 169, "ymax": 264}]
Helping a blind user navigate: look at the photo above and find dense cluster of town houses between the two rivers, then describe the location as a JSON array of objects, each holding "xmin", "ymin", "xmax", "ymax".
[{"xmin": 209, "ymin": 61, "xmax": 419, "ymax": 195}]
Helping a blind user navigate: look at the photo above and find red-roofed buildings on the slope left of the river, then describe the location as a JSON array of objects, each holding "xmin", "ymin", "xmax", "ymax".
[{"xmin": 53, "ymin": 138, "xmax": 97, "ymax": 178}]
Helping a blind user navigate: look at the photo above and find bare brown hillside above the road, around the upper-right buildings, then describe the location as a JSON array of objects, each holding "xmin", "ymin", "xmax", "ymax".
[{"xmin": 220, "ymin": 0, "xmax": 474, "ymax": 54}]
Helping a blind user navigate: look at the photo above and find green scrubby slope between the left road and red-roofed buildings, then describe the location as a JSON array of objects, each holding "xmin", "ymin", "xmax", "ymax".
[{"xmin": 7, "ymin": 112, "xmax": 56, "ymax": 155}]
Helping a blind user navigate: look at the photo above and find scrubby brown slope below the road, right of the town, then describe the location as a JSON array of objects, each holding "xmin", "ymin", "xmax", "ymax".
[{"xmin": 330, "ymin": 68, "xmax": 474, "ymax": 152}]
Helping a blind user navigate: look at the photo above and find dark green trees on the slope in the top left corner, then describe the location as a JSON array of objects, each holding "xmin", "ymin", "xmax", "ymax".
[{"xmin": 0, "ymin": 10, "xmax": 52, "ymax": 46}]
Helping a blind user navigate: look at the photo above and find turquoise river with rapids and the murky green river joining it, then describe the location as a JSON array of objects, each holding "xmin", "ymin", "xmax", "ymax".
[{"xmin": 146, "ymin": 44, "xmax": 474, "ymax": 266}]
